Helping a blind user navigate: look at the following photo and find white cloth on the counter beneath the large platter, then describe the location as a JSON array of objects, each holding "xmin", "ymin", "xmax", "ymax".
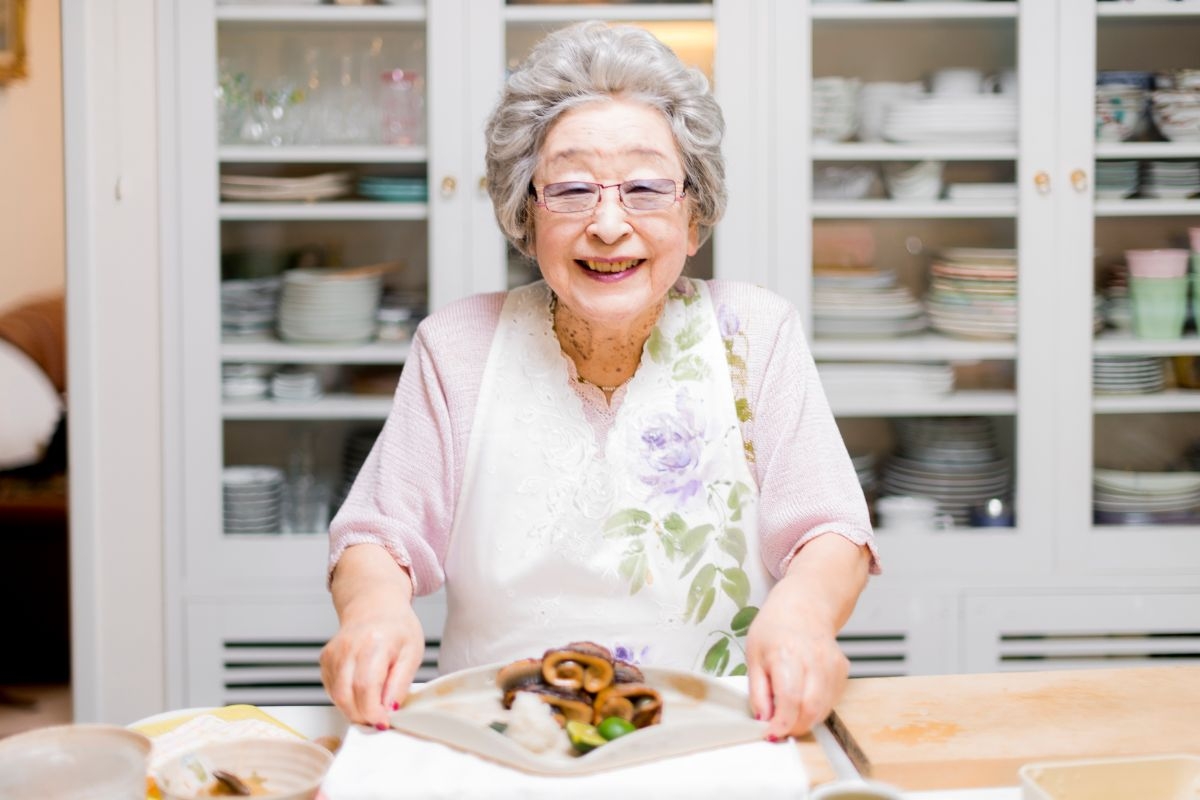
[{"xmin": 322, "ymin": 726, "xmax": 809, "ymax": 800}]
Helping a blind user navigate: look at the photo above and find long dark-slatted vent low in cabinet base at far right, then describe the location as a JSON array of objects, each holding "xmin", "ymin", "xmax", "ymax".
[{"xmin": 1000, "ymin": 630, "xmax": 1200, "ymax": 669}]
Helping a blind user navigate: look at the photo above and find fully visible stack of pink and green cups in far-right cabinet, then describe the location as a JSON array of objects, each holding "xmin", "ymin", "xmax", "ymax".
[{"xmin": 1126, "ymin": 249, "xmax": 1188, "ymax": 339}]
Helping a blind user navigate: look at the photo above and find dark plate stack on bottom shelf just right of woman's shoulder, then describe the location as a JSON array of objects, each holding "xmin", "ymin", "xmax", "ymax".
[{"xmin": 882, "ymin": 417, "xmax": 1013, "ymax": 525}]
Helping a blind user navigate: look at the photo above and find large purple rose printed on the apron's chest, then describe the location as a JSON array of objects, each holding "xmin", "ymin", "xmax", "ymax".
[{"xmin": 638, "ymin": 392, "xmax": 704, "ymax": 503}]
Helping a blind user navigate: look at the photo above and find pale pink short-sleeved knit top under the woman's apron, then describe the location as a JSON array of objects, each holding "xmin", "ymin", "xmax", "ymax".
[{"xmin": 329, "ymin": 281, "xmax": 880, "ymax": 595}]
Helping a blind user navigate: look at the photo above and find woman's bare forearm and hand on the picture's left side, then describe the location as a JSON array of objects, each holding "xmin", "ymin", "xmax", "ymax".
[{"xmin": 320, "ymin": 545, "xmax": 425, "ymax": 728}]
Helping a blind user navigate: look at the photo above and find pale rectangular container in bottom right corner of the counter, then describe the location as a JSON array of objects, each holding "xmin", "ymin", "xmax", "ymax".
[{"xmin": 1018, "ymin": 756, "xmax": 1200, "ymax": 800}]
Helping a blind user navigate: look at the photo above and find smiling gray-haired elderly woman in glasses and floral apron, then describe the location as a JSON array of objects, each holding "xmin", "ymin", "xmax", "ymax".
[{"xmin": 322, "ymin": 23, "xmax": 876, "ymax": 738}]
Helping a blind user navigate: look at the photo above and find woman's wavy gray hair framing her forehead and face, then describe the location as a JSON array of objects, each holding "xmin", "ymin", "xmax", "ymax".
[{"xmin": 485, "ymin": 22, "xmax": 726, "ymax": 255}]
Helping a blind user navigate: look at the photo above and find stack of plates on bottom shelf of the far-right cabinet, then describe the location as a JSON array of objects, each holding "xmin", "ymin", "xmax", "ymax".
[{"xmin": 1092, "ymin": 468, "xmax": 1200, "ymax": 524}]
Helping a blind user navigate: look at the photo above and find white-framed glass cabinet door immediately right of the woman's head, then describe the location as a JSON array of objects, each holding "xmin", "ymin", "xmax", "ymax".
[{"xmin": 775, "ymin": 0, "xmax": 1054, "ymax": 575}]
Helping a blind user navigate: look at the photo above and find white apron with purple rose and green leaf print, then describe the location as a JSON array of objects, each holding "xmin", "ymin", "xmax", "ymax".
[{"xmin": 439, "ymin": 279, "xmax": 770, "ymax": 674}]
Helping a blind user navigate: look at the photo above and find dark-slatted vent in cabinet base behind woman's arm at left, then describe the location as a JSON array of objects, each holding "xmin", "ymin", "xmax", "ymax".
[{"xmin": 221, "ymin": 639, "xmax": 442, "ymax": 705}]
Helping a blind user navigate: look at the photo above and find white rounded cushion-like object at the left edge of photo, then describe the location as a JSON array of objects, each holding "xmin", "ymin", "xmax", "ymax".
[{"xmin": 0, "ymin": 339, "xmax": 62, "ymax": 469}]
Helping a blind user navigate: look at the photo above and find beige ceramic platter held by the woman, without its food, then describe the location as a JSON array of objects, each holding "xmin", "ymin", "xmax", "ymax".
[{"xmin": 391, "ymin": 664, "xmax": 767, "ymax": 775}]
